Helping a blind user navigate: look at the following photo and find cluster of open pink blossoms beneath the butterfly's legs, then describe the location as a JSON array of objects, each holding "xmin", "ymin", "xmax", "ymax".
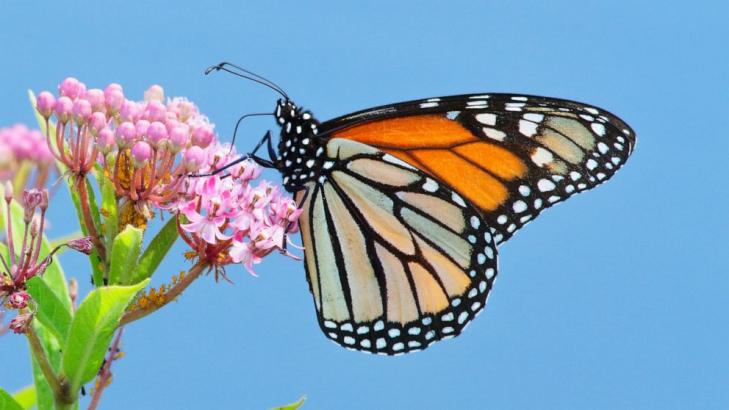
[{"xmin": 172, "ymin": 142, "xmax": 301, "ymax": 275}]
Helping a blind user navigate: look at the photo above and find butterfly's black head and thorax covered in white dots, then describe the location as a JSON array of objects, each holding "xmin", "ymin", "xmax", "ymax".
[{"xmin": 275, "ymin": 100, "xmax": 324, "ymax": 192}]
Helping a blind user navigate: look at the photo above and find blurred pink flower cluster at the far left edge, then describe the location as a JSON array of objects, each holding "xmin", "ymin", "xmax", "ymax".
[{"xmin": 0, "ymin": 124, "xmax": 53, "ymax": 187}]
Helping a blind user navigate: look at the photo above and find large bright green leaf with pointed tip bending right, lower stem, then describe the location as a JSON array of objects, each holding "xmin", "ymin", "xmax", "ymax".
[{"xmin": 63, "ymin": 280, "xmax": 149, "ymax": 391}]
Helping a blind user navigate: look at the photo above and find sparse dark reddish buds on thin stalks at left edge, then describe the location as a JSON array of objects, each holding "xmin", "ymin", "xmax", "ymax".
[{"xmin": 0, "ymin": 182, "xmax": 92, "ymax": 333}]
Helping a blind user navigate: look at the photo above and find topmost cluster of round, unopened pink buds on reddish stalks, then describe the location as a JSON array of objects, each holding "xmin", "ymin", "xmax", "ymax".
[{"xmin": 36, "ymin": 78, "xmax": 215, "ymax": 223}]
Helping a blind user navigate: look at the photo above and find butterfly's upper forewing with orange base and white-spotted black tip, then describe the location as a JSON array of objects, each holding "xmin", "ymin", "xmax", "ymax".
[{"xmin": 320, "ymin": 94, "xmax": 635, "ymax": 243}]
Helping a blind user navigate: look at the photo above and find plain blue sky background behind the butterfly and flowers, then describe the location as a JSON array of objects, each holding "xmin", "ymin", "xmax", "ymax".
[{"xmin": 0, "ymin": 1, "xmax": 729, "ymax": 409}]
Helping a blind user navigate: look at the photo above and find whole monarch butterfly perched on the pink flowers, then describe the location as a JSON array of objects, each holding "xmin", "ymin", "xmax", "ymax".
[{"xmin": 208, "ymin": 63, "xmax": 636, "ymax": 355}]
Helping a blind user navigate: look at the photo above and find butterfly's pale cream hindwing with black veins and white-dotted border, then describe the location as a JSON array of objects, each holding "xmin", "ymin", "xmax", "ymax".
[{"xmin": 297, "ymin": 138, "xmax": 496, "ymax": 354}]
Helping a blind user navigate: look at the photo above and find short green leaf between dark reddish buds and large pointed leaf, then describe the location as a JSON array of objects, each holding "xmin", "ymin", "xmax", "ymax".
[{"xmin": 27, "ymin": 276, "xmax": 72, "ymax": 340}]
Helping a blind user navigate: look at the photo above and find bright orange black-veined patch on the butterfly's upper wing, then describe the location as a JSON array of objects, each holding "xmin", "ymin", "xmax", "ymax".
[{"xmin": 333, "ymin": 115, "xmax": 527, "ymax": 211}]
